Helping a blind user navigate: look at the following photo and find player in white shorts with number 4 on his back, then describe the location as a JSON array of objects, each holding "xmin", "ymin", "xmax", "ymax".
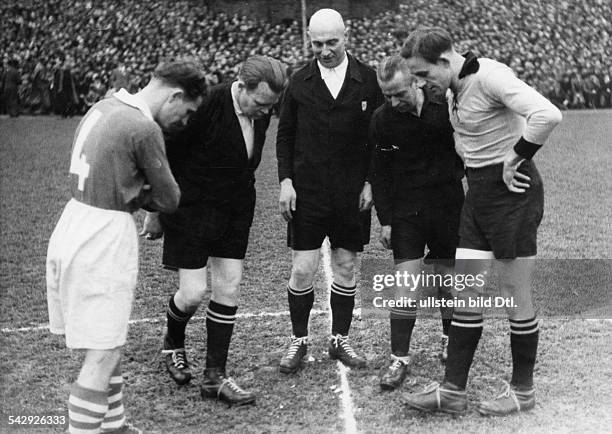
[{"xmin": 47, "ymin": 61, "xmax": 205, "ymax": 433}]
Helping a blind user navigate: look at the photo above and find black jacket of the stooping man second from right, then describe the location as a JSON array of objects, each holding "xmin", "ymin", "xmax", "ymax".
[{"xmin": 370, "ymin": 87, "xmax": 464, "ymax": 225}]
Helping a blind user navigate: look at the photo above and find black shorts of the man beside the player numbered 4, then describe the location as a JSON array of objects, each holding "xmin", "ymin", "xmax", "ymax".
[{"xmin": 162, "ymin": 193, "xmax": 255, "ymax": 270}]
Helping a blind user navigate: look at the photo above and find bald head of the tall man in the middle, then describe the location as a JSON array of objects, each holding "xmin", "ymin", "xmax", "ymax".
[{"xmin": 308, "ymin": 9, "xmax": 346, "ymax": 68}]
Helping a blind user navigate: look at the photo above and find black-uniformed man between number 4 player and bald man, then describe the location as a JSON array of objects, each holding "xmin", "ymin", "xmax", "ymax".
[{"xmin": 145, "ymin": 56, "xmax": 287, "ymax": 405}]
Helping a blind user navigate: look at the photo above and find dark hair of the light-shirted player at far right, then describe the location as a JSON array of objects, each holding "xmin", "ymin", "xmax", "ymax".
[{"xmin": 401, "ymin": 27, "xmax": 453, "ymax": 63}]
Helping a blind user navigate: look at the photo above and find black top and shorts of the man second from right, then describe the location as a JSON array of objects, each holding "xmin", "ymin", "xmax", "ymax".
[{"xmin": 370, "ymin": 86, "xmax": 464, "ymax": 261}]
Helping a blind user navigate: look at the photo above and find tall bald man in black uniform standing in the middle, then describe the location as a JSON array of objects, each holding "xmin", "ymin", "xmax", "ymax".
[{"xmin": 276, "ymin": 9, "xmax": 382, "ymax": 373}]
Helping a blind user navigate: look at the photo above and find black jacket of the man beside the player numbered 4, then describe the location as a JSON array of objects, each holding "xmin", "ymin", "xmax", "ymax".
[{"xmin": 162, "ymin": 84, "xmax": 270, "ymax": 236}]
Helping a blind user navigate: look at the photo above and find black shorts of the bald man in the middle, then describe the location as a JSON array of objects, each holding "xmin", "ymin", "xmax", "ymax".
[{"xmin": 287, "ymin": 193, "xmax": 371, "ymax": 252}]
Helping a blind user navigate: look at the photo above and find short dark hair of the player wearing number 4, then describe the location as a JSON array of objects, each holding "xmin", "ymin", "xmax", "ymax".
[{"xmin": 153, "ymin": 59, "xmax": 206, "ymax": 100}]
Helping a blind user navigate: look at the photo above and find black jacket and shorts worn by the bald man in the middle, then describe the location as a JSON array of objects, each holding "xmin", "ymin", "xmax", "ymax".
[{"xmin": 276, "ymin": 54, "xmax": 383, "ymax": 252}]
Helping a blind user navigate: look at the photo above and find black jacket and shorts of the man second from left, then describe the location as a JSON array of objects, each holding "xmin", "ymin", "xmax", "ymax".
[{"xmin": 161, "ymin": 83, "xmax": 270, "ymax": 269}]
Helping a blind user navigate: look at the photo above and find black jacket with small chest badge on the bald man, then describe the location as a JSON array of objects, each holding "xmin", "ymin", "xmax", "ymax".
[{"xmin": 276, "ymin": 55, "xmax": 383, "ymax": 200}]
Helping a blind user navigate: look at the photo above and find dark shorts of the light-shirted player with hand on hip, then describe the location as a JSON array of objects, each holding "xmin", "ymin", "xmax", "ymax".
[{"xmin": 459, "ymin": 161, "xmax": 544, "ymax": 259}]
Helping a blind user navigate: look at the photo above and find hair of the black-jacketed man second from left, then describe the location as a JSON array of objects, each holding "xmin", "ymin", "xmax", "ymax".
[{"xmin": 238, "ymin": 56, "xmax": 289, "ymax": 93}]
